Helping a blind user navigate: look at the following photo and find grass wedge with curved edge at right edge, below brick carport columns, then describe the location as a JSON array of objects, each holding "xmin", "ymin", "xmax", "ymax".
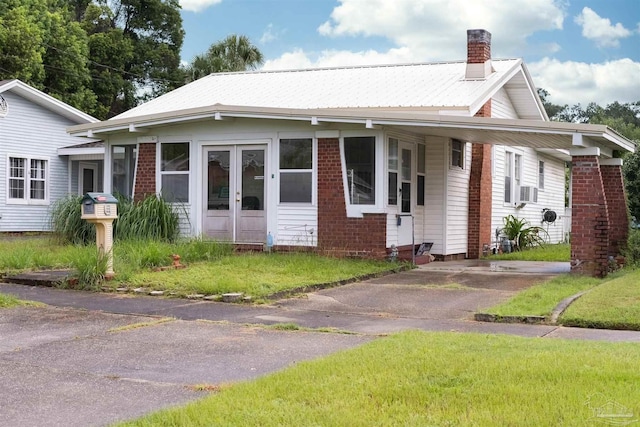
[{"xmin": 560, "ymin": 270, "xmax": 640, "ymax": 331}]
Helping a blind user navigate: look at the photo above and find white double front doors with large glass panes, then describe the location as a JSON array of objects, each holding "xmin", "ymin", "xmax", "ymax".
[{"xmin": 203, "ymin": 145, "xmax": 267, "ymax": 243}]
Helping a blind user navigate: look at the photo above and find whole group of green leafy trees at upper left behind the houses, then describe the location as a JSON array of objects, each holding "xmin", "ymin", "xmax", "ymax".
[{"xmin": 0, "ymin": 0, "xmax": 185, "ymax": 119}]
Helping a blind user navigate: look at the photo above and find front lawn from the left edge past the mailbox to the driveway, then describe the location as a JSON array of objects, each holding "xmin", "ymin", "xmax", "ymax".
[{"xmin": 0, "ymin": 238, "xmax": 402, "ymax": 299}]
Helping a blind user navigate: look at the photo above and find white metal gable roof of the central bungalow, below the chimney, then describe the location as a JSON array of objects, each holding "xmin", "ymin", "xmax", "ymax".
[{"xmin": 113, "ymin": 59, "xmax": 546, "ymax": 120}]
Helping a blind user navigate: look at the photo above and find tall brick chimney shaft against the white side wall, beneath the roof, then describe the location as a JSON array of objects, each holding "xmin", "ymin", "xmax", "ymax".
[{"xmin": 467, "ymin": 100, "xmax": 493, "ymax": 259}]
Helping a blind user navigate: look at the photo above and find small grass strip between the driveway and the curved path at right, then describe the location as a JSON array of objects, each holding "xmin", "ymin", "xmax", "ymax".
[{"xmin": 486, "ymin": 274, "xmax": 606, "ymax": 316}]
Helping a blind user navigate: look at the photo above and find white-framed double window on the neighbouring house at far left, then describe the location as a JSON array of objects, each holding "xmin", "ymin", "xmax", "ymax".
[{"xmin": 7, "ymin": 156, "xmax": 48, "ymax": 204}]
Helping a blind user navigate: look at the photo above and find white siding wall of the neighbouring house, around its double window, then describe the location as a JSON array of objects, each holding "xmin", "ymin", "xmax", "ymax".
[{"xmin": 0, "ymin": 91, "xmax": 85, "ymax": 232}]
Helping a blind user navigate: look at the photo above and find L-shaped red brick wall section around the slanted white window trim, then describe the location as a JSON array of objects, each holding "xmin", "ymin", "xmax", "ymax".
[{"xmin": 318, "ymin": 138, "xmax": 387, "ymax": 258}]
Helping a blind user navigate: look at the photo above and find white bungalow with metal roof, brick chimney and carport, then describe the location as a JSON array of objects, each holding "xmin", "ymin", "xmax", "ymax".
[{"xmin": 69, "ymin": 30, "xmax": 634, "ymax": 278}]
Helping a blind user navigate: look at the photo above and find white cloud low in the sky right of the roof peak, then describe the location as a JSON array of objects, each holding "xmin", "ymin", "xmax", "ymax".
[{"xmin": 527, "ymin": 58, "xmax": 640, "ymax": 106}]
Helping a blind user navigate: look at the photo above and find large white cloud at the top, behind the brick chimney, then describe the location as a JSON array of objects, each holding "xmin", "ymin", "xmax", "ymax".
[{"xmin": 318, "ymin": 0, "xmax": 565, "ymax": 60}]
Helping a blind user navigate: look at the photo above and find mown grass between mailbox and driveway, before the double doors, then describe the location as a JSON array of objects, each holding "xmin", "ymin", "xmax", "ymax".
[{"xmin": 116, "ymin": 253, "xmax": 397, "ymax": 298}]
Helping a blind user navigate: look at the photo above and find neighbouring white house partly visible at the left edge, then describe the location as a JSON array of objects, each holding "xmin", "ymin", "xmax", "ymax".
[{"xmin": 0, "ymin": 80, "xmax": 104, "ymax": 232}]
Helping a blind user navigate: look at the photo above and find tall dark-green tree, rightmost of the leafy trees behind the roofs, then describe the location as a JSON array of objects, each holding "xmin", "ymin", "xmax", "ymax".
[{"xmin": 81, "ymin": 0, "xmax": 184, "ymax": 117}]
